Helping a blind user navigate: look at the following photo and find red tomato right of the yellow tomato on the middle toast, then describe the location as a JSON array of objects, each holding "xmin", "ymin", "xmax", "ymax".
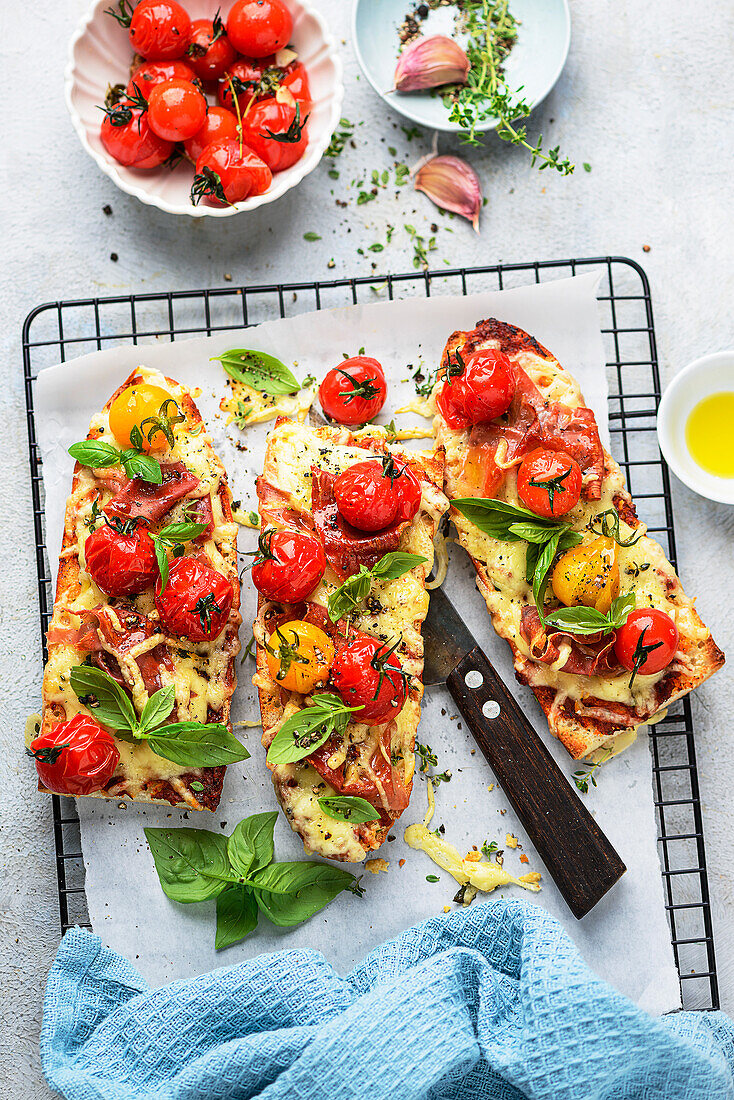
[{"xmin": 331, "ymin": 634, "xmax": 406, "ymax": 726}]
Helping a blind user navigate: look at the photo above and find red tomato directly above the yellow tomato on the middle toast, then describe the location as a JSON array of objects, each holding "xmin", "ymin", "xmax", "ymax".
[{"xmin": 252, "ymin": 530, "xmax": 326, "ymax": 604}]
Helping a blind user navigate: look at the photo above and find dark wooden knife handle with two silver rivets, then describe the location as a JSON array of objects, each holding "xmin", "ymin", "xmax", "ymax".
[{"xmin": 447, "ymin": 646, "xmax": 626, "ymax": 919}]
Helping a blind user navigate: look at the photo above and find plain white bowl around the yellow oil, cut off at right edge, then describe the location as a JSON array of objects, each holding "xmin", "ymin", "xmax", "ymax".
[{"xmin": 657, "ymin": 351, "xmax": 734, "ymax": 504}]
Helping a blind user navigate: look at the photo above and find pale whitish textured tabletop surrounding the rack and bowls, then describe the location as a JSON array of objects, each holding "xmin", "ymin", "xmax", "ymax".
[{"xmin": 0, "ymin": 0, "xmax": 734, "ymax": 1100}]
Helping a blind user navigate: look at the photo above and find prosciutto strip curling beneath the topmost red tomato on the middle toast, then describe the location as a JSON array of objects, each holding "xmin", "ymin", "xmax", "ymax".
[{"xmin": 311, "ymin": 466, "xmax": 409, "ymax": 580}]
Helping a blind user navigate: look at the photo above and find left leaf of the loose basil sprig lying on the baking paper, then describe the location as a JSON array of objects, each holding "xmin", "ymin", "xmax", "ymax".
[{"xmin": 144, "ymin": 828, "xmax": 232, "ymax": 904}]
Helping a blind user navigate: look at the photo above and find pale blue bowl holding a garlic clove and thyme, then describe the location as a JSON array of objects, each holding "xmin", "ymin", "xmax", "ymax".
[{"xmin": 352, "ymin": 0, "xmax": 571, "ymax": 132}]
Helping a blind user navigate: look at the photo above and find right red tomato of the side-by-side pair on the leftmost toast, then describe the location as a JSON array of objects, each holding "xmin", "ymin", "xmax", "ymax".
[{"xmin": 155, "ymin": 558, "xmax": 234, "ymax": 641}]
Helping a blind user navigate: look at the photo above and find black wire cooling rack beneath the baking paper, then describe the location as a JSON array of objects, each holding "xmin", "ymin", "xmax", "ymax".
[{"xmin": 23, "ymin": 256, "xmax": 719, "ymax": 1009}]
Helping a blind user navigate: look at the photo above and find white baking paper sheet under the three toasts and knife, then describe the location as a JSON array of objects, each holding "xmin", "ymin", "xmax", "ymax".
[{"xmin": 35, "ymin": 273, "xmax": 680, "ymax": 1013}]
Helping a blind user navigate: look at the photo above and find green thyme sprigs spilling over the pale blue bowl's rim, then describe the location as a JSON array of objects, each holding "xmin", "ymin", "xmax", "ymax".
[{"xmin": 445, "ymin": 0, "xmax": 574, "ymax": 176}]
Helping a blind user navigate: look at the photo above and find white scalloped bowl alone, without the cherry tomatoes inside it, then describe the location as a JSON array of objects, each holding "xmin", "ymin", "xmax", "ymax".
[{"xmin": 65, "ymin": 0, "xmax": 344, "ymax": 218}]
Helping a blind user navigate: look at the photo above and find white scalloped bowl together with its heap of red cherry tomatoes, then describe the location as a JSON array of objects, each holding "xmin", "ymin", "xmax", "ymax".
[{"xmin": 66, "ymin": 0, "xmax": 343, "ymax": 218}]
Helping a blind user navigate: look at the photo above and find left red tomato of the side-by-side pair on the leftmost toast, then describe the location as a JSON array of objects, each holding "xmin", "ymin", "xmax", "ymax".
[{"xmin": 84, "ymin": 519, "xmax": 158, "ymax": 596}]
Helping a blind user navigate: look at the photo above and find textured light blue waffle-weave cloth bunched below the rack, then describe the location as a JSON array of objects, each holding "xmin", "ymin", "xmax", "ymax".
[{"xmin": 41, "ymin": 901, "xmax": 734, "ymax": 1100}]
